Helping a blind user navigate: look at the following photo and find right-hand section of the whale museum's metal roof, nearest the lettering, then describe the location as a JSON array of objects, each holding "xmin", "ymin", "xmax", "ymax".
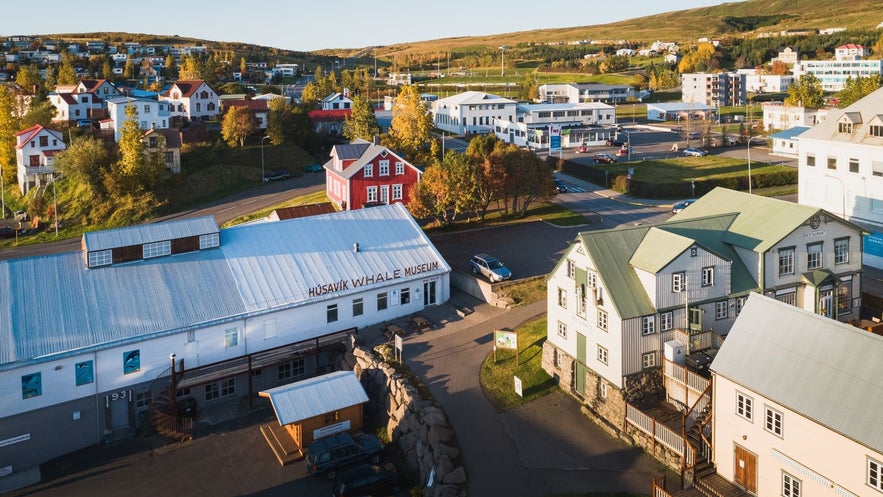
[{"xmin": 221, "ymin": 204, "xmax": 450, "ymax": 311}]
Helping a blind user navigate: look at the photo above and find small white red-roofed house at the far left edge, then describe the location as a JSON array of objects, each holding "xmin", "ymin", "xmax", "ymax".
[{"xmin": 15, "ymin": 124, "xmax": 67, "ymax": 194}]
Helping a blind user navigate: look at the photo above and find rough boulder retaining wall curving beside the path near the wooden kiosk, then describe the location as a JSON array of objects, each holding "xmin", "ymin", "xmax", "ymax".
[{"xmin": 346, "ymin": 346, "xmax": 467, "ymax": 497}]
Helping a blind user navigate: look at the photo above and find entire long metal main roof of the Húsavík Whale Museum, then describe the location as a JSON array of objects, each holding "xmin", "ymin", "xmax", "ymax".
[{"xmin": 0, "ymin": 204, "xmax": 450, "ymax": 370}]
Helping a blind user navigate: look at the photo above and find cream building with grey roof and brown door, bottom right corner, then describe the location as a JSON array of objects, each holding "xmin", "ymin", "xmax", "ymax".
[{"xmin": 711, "ymin": 294, "xmax": 883, "ymax": 497}]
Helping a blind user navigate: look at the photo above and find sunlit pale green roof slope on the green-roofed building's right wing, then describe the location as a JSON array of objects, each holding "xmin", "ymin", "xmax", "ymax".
[{"xmin": 667, "ymin": 187, "xmax": 824, "ymax": 253}]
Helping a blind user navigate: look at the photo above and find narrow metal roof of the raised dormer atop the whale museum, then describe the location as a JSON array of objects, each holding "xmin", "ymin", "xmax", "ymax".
[{"xmin": 83, "ymin": 216, "xmax": 219, "ymax": 252}]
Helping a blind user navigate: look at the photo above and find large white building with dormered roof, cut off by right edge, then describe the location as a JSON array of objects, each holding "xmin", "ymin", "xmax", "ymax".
[{"xmin": 797, "ymin": 89, "xmax": 883, "ymax": 267}]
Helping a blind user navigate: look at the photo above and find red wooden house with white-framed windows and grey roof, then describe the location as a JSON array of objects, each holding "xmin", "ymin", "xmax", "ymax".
[{"xmin": 325, "ymin": 140, "xmax": 423, "ymax": 210}]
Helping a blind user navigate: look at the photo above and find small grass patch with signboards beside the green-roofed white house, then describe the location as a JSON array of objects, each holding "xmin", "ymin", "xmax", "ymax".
[{"xmin": 480, "ymin": 316, "xmax": 558, "ymax": 412}]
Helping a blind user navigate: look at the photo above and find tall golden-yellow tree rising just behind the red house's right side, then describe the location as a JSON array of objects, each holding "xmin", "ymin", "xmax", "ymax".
[{"xmin": 384, "ymin": 85, "xmax": 433, "ymax": 164}]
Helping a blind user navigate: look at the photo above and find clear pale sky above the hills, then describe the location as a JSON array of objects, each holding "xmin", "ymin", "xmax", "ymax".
[{"xmin": 0, "ymin": 0, "xmax": 724, "ymax": 51}]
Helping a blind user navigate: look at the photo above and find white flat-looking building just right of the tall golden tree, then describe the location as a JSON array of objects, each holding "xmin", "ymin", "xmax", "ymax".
[{"xmin": 430, "ymin": 91, "xmax": 516, "ymax": 135}]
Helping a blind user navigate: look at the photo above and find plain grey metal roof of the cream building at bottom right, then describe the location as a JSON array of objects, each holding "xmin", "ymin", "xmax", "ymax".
[{"xmin": 711, "ymin": 294, "xmax": 883, "ymax": 452}]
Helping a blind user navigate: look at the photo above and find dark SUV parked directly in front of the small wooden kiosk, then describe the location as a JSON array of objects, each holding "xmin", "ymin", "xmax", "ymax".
[{"xmin": 306, "ymin": 433, "xmax": 383, "ymax": 480}]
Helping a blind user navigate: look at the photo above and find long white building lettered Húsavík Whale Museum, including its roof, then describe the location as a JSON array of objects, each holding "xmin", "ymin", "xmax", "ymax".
[{"xmin": 0, "ymin": 204, "xmax": 451, "ymax": 480}]
